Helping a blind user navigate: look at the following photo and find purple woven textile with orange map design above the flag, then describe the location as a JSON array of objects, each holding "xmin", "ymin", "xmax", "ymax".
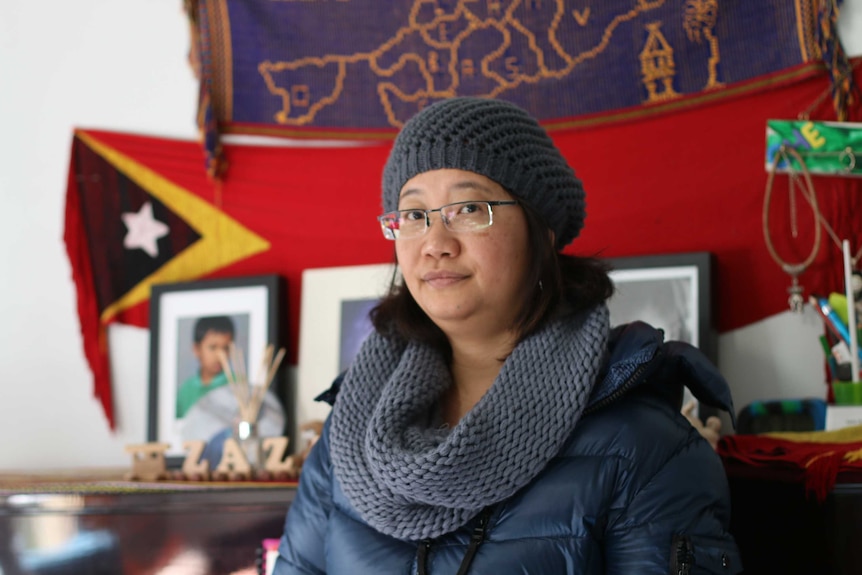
[{"xmin": 211, "ymin": 0, "xmax": 812, "ymax": 129}]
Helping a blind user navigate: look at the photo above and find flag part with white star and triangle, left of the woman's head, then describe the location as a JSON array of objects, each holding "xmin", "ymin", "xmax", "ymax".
[{"xmin": 64, "ymin": 130, "xmax": 392, "ymax": 428}]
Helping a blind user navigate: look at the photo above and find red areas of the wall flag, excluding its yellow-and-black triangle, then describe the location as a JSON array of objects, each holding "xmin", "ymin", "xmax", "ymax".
[{"xmin": 66, "ymin": 65, "xmax": 862, "ymax": 430}]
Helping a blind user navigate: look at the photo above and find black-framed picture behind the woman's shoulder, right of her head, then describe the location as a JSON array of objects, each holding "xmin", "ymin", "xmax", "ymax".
[{"xmin": 607, "ymin": 252, "xmax": 718, "ymax": 420}]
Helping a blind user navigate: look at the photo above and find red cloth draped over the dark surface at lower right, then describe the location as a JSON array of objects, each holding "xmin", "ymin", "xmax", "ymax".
[{"xmin": 717, "ymin": 435, "xmax": 862, "ymax": 501}]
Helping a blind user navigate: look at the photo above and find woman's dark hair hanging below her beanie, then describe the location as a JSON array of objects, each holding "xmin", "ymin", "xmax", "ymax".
[{"xmin": 371, "ymin": 200, "xmax": 614, "ymax": 360}]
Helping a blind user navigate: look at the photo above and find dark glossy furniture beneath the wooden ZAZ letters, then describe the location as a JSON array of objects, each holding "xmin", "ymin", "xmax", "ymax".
[{"xmin": 0, "ymin": 475, "xmax": 295, "ymax": 575}]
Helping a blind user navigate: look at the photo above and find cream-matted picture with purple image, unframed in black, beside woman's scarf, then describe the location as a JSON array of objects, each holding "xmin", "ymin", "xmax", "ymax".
[{"xmin": 296, "ymin": 264, "xmax": 395, "ymax": 434}]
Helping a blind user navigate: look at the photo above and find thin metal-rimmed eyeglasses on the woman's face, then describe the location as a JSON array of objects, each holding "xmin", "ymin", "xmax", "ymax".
[{"xmin": 377, "ymin": 200, "xmax": 518, "ymax": 240}]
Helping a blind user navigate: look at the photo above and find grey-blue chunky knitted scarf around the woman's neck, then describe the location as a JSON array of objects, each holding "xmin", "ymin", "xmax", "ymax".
[{"xmin": 330, "ymin": 304, "xmax": 609, "ymax": 540}]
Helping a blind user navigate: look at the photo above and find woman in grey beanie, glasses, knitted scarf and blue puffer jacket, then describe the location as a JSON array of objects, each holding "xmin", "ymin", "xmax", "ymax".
[{"xmin": 275, "ymin": 98, "xmax": 741, "ymax": 575}]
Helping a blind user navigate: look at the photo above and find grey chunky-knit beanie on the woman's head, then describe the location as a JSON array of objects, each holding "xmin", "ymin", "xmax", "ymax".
[{"xmin": 383, "ymin": 97, "xmax": 586, "ymax": 249}]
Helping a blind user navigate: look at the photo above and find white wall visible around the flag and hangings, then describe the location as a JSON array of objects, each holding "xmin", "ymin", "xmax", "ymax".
[{"xmin": 0, "ymin": 0, "xmax": 862, "ymax": 471}]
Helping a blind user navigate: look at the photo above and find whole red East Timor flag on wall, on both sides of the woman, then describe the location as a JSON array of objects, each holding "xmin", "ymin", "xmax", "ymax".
[{"xmin": 65, "ymin": 63, "xmax": 862, "ymax": 430}]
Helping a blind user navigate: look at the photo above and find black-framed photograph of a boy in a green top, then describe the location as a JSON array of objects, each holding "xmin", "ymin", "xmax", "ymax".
[{"xmin": 147, "ymin": 275, "xmax": 288, "ymax": 468}]
